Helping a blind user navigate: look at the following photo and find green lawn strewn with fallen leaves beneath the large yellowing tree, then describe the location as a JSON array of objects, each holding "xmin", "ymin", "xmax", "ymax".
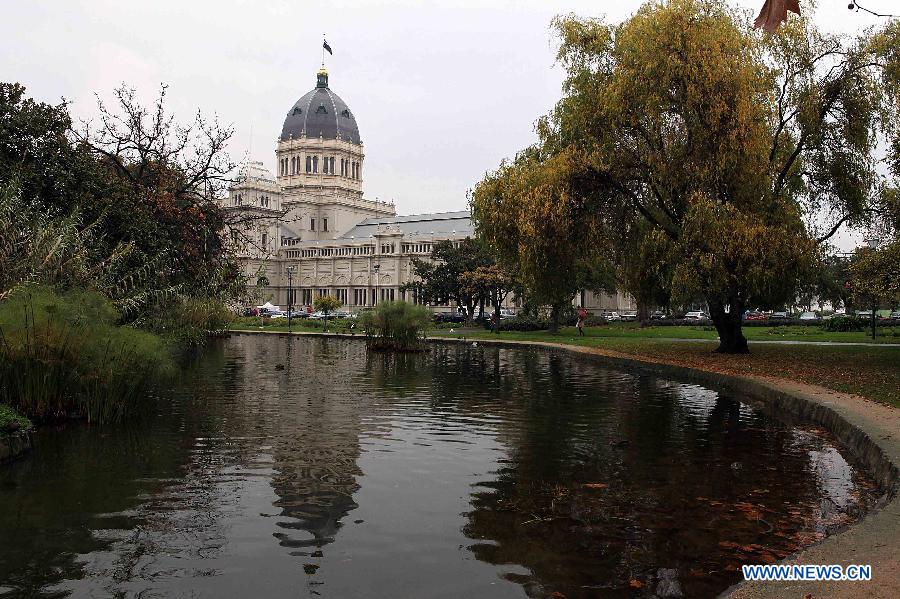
[{"xmin": 431, "ymin": 327, "xmax": 900, "ymax": 407}]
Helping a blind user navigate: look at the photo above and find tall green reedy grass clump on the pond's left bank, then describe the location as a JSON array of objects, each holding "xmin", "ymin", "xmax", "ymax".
[{"xmin": 0, "ymin": 286, "xmax": 174, "ymax": 423}]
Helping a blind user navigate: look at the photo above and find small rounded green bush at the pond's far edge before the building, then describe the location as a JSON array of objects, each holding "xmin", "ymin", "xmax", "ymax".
[{"xmin": 359, "ymin": 301, "xmax": 431, "ymax": 351}]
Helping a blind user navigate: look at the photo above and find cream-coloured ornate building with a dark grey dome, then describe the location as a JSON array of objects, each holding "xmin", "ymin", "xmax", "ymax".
[{"xmin": 223, "ymin": 67, "xmax": 633, "ymax": 311}]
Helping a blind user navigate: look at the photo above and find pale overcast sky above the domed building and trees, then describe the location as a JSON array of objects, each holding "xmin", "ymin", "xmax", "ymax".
[{"xmin": 0, "ymin": 0, "xmax": 897, "ymax": 248}]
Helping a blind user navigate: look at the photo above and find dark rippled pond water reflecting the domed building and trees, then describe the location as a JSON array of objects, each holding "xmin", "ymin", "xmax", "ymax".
[{"xmin": 0, "ymin": 336, "xmax": 876, "ymax": 599}]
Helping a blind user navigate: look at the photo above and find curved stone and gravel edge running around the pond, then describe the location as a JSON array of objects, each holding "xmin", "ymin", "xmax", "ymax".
[{"xmin": 232, "ymin": 330, "xmax": 900, "ymax": 598}]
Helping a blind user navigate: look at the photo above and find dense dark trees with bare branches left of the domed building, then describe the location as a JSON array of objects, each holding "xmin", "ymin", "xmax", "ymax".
[{"xmin": 0, "ymin": 83, "xmax": 243, "ymax": 320}]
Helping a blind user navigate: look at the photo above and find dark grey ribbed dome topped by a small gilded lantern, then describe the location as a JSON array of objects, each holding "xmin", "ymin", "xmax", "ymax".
[{"xmin": 279, "ymin": 67, "xmax": 360, "ymax": 144}]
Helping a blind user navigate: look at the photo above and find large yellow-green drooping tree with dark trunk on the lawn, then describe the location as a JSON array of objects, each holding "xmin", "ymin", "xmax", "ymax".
[{"xmin": 474, "ymin": 0, "xmax": 883, "ymax": 353}]
